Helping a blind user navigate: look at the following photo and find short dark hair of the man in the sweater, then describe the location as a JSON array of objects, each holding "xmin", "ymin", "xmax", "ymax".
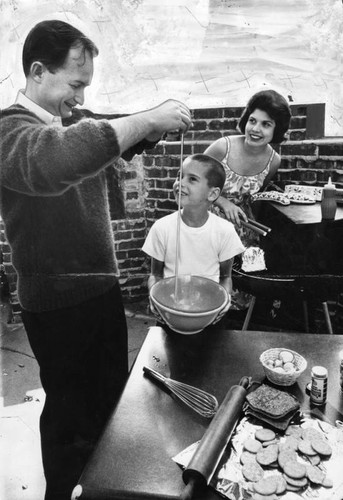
[{"xmin": 22, "ymin": 20, "xmax": 99, "ymax": 76}]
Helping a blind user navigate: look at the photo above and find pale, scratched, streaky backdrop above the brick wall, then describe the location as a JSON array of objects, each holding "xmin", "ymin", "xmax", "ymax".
[{"xmin": 0, "ymin": 0, "xmax": 343, "ymax": 136}]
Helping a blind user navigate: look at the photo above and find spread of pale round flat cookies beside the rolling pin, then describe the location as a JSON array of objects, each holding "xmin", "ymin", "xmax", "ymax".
[{"xmin": 240, "ymin": 425, "xmax": 333, "ymax": 500}]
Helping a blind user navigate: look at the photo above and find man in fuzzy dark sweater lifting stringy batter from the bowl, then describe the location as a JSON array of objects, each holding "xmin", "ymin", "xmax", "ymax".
[{"xmin": 0, "ymin": 21, "xmax": 191, "ymax": 500}]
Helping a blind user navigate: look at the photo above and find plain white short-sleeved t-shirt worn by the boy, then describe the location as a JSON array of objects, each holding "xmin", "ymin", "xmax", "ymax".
[{"xmin": 142, "ymin": 212, "xmax": 245, "ymax": 282}]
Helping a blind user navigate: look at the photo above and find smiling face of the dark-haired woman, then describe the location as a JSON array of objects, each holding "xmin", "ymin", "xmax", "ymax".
[{"xmin": 245, "ymin": 109, "xmax": 276, "ymax": 146}]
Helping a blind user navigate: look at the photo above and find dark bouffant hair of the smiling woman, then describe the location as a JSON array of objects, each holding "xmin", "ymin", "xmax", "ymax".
[{"xmin": 238, "ymin": 90, "xmax": 292, "ymax": 144}]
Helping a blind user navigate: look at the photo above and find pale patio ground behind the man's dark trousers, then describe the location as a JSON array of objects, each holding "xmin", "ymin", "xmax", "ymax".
[{"xmin": 0, "ymin": 296, "xmax": 155, "ymax": 500}]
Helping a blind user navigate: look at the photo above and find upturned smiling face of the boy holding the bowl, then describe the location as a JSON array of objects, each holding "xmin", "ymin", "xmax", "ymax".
[{"xmin": 173, "ymin": 159, "xmax": 219, "ymax": 207}]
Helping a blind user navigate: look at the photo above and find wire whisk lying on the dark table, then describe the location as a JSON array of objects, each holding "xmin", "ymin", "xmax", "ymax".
[{"xmin": 143, "ymin": 366, "xmax": 218, "ymax": 418}]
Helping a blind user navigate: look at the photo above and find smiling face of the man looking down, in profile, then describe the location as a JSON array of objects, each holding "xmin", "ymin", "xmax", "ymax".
[{"xmin": 37, "ymin": 46, "xmax": 93, "ymax": 118}]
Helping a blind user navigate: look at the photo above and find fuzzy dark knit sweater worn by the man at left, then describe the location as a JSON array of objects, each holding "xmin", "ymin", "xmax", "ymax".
[{"xmin": 0, "ymin": 105, "xmax": 151, "ymax": 312}]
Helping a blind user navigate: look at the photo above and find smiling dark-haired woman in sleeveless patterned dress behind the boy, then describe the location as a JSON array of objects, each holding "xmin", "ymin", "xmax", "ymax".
[{"xmin": 205, "ymin": 90, "xmax": 291, "ymax": 309}]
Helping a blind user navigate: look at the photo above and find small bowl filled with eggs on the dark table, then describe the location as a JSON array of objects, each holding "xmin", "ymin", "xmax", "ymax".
[{"xmin": 260, "ymin": 347, "xmax": 307, "ymax": 386}]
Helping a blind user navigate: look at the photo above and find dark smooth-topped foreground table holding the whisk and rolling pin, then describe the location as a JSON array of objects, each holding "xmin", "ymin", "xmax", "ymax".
[{"xmin": 73, "ymin": 327, "xmax": 343, "ymax": 500}]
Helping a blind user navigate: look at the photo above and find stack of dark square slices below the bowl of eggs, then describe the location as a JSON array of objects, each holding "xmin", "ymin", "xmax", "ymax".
[{"xmin": 244, "ymin": 384, "xmax": 300, "ymax": 430}]
